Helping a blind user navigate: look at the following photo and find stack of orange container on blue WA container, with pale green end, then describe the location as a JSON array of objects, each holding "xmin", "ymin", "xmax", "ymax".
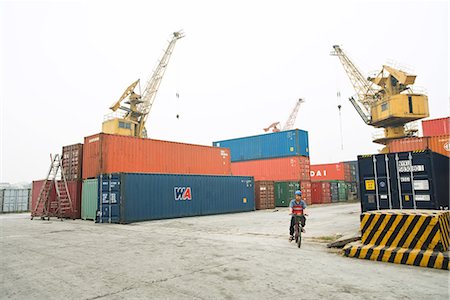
[{"xmin": 82, "ymin": 133, "xmax": 251, "ymax": 223}]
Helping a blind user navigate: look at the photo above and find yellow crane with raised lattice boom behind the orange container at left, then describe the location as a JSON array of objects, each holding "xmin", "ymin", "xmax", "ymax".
[{"xmin": 102, "ymin": 31, "xmax": 184, "ymax": 138}]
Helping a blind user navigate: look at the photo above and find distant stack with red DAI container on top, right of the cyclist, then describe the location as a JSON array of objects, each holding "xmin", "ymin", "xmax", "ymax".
[{"xmin": 311, "ymin": 161, "xmax": 358, "ymax": 204}]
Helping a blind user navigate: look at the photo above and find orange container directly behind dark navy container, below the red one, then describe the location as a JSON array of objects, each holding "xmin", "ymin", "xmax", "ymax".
[{"xmin": 388, "ymin": 135, "xmax": 450, "ymax": 157}]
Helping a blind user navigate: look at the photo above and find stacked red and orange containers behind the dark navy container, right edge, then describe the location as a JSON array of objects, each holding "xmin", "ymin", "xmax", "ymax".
[{"xmin": 388, "ymin": 117, "xmax": 450, "ymax": 157}]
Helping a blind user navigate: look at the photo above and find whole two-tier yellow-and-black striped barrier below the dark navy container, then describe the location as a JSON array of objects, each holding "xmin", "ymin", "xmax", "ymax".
[{"xmin": 343, "ymin": 210, "xmax": 450, "ymax": 270}]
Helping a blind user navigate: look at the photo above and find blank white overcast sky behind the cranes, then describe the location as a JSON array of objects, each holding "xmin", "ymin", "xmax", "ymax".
[{"xmin": 0, "ymin": 0, "xmax": 449, "ymax": 183}]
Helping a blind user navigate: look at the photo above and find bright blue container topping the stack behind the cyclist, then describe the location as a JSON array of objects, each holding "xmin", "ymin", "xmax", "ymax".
[{"xmin": 213, "ymin": 129, "xmax": 309, "ymax": 162}]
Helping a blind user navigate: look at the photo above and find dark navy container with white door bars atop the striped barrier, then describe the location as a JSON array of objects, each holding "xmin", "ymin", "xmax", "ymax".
[{"xmin": 358, "ymin": 150, "xmax": 449, "ymax": 212}]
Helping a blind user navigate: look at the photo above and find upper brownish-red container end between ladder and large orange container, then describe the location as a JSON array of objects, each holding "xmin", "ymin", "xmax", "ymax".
[{"xmin": 62, "ymin": 144, "xmax": 83, "ymax": 181}]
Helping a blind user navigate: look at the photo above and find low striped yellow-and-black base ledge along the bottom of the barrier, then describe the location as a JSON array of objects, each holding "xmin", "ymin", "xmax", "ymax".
[{"xmin": 343, "ymin": 242, "xmax": 449, "ymax": 270}]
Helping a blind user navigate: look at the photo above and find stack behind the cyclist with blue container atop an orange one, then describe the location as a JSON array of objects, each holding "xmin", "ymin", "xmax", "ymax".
[{"xmin": 213, "ymin": 129, "xmax": 311, "ymax": 209}]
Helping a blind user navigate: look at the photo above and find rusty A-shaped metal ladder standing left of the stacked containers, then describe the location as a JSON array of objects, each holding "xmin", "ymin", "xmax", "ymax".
[{"xmin": 31, "ymin": 154, "xmax": 73, "ymax": 221}]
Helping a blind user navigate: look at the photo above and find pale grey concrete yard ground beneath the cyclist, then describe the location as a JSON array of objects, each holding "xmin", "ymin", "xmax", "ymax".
[{"xmin": 0, "ymin": 203, "xmax": 449, "ymax": 300}]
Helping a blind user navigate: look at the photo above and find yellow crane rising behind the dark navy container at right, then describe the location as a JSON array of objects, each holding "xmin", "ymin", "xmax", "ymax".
[{"xmin": 331, "ymin": 45, "xmax": 429, "ymax": 148}]
